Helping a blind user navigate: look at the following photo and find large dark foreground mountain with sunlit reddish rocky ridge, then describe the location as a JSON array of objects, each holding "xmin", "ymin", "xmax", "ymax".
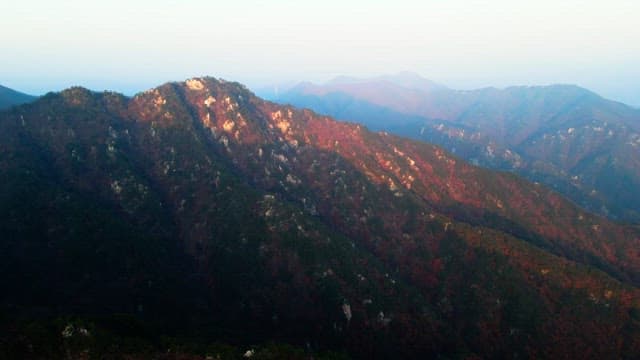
[{"xmin": 0, "ymin": 78, "xmax": 640, "ymax": 358}]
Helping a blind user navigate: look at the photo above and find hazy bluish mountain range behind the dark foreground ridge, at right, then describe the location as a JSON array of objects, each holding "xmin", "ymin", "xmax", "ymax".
[{"xmin": 274, "ymin": 74, "xmax": 640, "ymax": 222}]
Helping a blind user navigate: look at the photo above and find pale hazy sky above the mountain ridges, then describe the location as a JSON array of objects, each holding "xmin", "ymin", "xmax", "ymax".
[{"xmin": 0, "ymin": 0, "xmax": 640, "ymax": 106}]
